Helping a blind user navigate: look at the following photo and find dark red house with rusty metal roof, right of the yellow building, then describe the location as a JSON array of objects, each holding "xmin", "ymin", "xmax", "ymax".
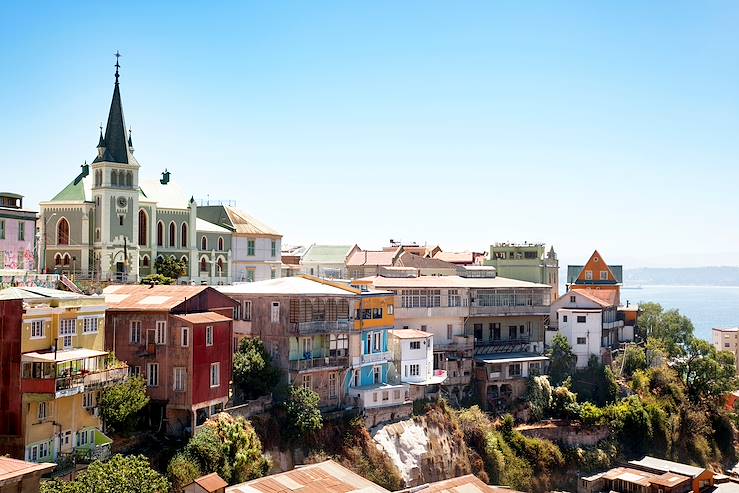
[{"xmin": 103, "ymin": 285, "xmax": 236, "ymax": 434}]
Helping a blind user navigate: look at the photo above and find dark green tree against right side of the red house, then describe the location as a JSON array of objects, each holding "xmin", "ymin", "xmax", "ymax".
[{"xmin": 233, "ymin": 338, "xmax": 280, "ymax": 399}]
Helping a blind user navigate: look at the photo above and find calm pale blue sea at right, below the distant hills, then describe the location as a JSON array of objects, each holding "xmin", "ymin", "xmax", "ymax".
[{"xmin": 621, "ymin": 286, "xmax": 739, "ymax": 342}]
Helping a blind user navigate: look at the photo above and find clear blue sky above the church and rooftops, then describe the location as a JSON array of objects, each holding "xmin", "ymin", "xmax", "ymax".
[{"xmin": 0, "ymin": 0, "xmax": 739, "ymax": 267}]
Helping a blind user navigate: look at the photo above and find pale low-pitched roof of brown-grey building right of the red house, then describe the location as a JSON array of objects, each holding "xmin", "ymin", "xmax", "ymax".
[{"xmin": 215, "ymin": 276, "xmax": 359, "ymax": 296}]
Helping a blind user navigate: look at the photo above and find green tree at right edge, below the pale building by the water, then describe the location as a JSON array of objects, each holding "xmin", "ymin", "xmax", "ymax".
[{"xmin": 675, "ymin": 337, "xmax": 739, "ymax": 402}]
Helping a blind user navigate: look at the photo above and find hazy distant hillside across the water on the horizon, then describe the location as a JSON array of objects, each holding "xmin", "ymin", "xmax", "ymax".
[{"xmin": 624, "ymin": 267, "xmax": 739, "ymax": 286}]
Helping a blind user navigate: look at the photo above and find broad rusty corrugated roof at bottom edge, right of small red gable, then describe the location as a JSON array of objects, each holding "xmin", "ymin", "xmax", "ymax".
[{"xmin": 226, "ymin": 460, "xmax": 389, "ymax": 493}]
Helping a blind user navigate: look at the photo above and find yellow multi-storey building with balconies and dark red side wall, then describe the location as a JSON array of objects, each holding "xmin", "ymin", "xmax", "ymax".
[{"xmin": 0, "ymin": 287, "xmax": 128, "ymax": 462}]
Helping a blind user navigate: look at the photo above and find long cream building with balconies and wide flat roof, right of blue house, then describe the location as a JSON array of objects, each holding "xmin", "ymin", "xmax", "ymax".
[{"xmin": 354, "ymin": 271, "xmax": 550, "ymax": 399}]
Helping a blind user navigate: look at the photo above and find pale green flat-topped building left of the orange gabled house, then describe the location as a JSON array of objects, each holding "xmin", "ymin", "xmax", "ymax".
[{"xmin": 484, "ymin": 243, "xmax": 559, "ymax": 300}]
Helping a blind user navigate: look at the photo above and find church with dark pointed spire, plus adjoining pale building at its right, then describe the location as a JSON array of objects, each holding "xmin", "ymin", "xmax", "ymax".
[{"xmin": 38, "ymin": 54, "xmax": 281, "ymax": 285}]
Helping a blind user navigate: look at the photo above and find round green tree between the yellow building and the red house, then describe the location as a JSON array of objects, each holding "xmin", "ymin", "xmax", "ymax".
[{"xmin": 100, "ymin": 377, "xmax": 149, "ymax": 431}]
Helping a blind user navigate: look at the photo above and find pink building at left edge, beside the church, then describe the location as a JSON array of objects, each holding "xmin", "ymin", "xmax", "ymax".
[{"xmin": 0, "ymin": 192, "xmax": 36, "ymax": 270}]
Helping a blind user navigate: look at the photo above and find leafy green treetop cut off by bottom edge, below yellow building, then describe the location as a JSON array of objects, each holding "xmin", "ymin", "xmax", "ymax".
[{"xmin": 41, "ymin": 454, "xmax": 170, "ymax": 493}]
